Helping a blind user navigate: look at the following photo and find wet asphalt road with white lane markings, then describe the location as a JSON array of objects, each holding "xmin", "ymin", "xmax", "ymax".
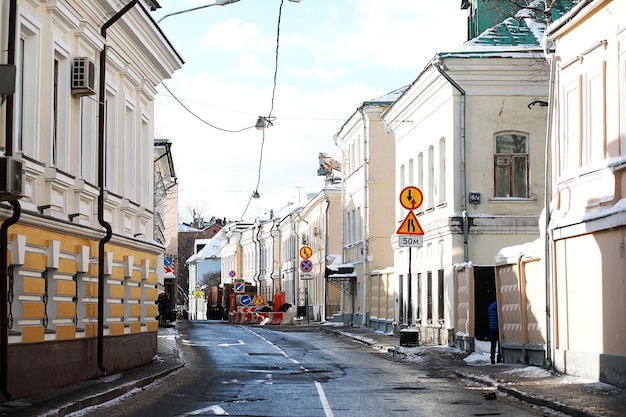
[{"xmin": 74, "ymin": 321, "xmax": 556, "ymax": 417}]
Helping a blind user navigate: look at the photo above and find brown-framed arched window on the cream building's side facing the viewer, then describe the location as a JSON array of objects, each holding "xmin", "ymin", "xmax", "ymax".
[{"xmin": 493, "ymin": 132, "xmax": 528, "ymax": 198}]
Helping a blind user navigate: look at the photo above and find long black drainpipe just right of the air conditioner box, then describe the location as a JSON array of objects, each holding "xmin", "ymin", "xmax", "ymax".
[{"xmin": 98, "ymin": 0, "xmax": 138, "ymax": 373}]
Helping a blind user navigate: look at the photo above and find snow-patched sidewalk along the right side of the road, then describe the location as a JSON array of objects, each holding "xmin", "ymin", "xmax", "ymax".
[{"xmin": 320, "ymin": 323, "xmax": 626, "ymax": 417}]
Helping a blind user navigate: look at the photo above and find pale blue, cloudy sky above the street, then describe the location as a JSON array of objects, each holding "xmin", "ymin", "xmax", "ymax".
[{"xmin": 152, "ymin": 0, "xmax": 467, "ymax": 222}]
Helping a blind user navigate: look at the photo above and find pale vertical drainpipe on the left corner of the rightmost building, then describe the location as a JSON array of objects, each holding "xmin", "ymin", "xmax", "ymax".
[{"xmin": 543, "ymin": 36, "xmax": 556, "ymax": 369}]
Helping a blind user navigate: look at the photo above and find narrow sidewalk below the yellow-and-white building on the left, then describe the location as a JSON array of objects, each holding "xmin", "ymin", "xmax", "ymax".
[{"xmin": 0, "ymin": 326, "xmax": 184, "ymax": 417}]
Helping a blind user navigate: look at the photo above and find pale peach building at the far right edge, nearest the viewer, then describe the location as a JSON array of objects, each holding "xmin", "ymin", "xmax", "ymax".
[{"xmin": 548, "ymin": 0, "xmax": 626, "ymax": 386}]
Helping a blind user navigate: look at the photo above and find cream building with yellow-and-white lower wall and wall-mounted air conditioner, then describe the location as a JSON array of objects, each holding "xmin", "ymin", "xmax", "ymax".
[{"xmin": 0, "ymin": 0, "xmax": 182, "ymax": 399}]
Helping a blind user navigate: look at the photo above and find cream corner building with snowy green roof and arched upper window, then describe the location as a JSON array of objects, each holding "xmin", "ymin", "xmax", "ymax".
[{"xmin": 383, "ymin": 7, "xmax": 548, "ymax": 344}]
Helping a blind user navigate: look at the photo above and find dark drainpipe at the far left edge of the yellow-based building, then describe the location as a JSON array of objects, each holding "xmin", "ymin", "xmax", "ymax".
[{"xmin": 0, "ymin": 0, "xmax": 22, "ymax": 400}]
